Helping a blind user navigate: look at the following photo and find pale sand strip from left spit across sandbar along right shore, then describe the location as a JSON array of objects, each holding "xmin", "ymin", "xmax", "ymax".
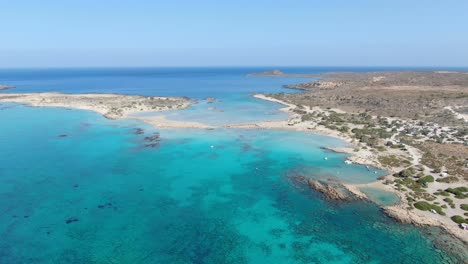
[{"xmin": 0, "ymin": 90, "xmax": 468, "ymax": 243}]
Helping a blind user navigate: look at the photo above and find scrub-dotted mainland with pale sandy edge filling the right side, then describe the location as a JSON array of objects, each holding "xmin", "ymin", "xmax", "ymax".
[{"xmin": 247, "ymin": 71, "xmax": 468, "ymax": 242}]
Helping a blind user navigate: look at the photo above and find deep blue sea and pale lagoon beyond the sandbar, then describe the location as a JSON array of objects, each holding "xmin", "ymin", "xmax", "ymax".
[{"xmin": 0, "ymin": 67, "xmax": 309, "ymax": 125}]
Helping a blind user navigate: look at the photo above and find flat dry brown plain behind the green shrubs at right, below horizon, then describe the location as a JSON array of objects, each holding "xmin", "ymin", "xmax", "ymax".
[{"xmin": 273, "ymin": 72, "xmax": 468, "ymax": 125}]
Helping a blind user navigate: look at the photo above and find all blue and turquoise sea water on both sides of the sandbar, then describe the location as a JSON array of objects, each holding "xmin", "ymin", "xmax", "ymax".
[{"xmin": 0, "ymin": 67, "xmax": 460, "ymax": 264}]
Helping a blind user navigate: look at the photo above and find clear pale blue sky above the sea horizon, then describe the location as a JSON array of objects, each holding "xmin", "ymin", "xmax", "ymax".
[{"xmin": 0, "ymin": 0, "xmax": 468, "ymax": 68}]
